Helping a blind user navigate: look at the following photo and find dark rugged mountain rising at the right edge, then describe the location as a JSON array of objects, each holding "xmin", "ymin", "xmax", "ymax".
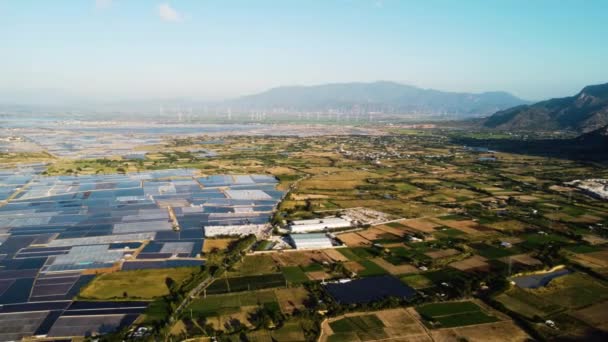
[{"xmin": 483, "ymin": 83, "xmax": 608, "ymax": 133}]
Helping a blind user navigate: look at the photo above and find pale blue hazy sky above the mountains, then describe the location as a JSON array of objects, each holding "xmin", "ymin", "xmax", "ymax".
[{"xmin": 0, "ymin": 0, "xmax": 608, "ymax": 100}]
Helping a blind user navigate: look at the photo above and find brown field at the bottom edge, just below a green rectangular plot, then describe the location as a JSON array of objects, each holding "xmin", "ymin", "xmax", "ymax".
[{"xmin": 431, "ymin": 321, "xmax": 530, "ymax": 342}]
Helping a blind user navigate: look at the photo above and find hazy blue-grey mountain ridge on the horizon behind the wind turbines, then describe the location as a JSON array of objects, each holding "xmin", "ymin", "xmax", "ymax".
[{"xmin": 222, "ymin": 81, "xmax": 527, "ymax": 118}]
